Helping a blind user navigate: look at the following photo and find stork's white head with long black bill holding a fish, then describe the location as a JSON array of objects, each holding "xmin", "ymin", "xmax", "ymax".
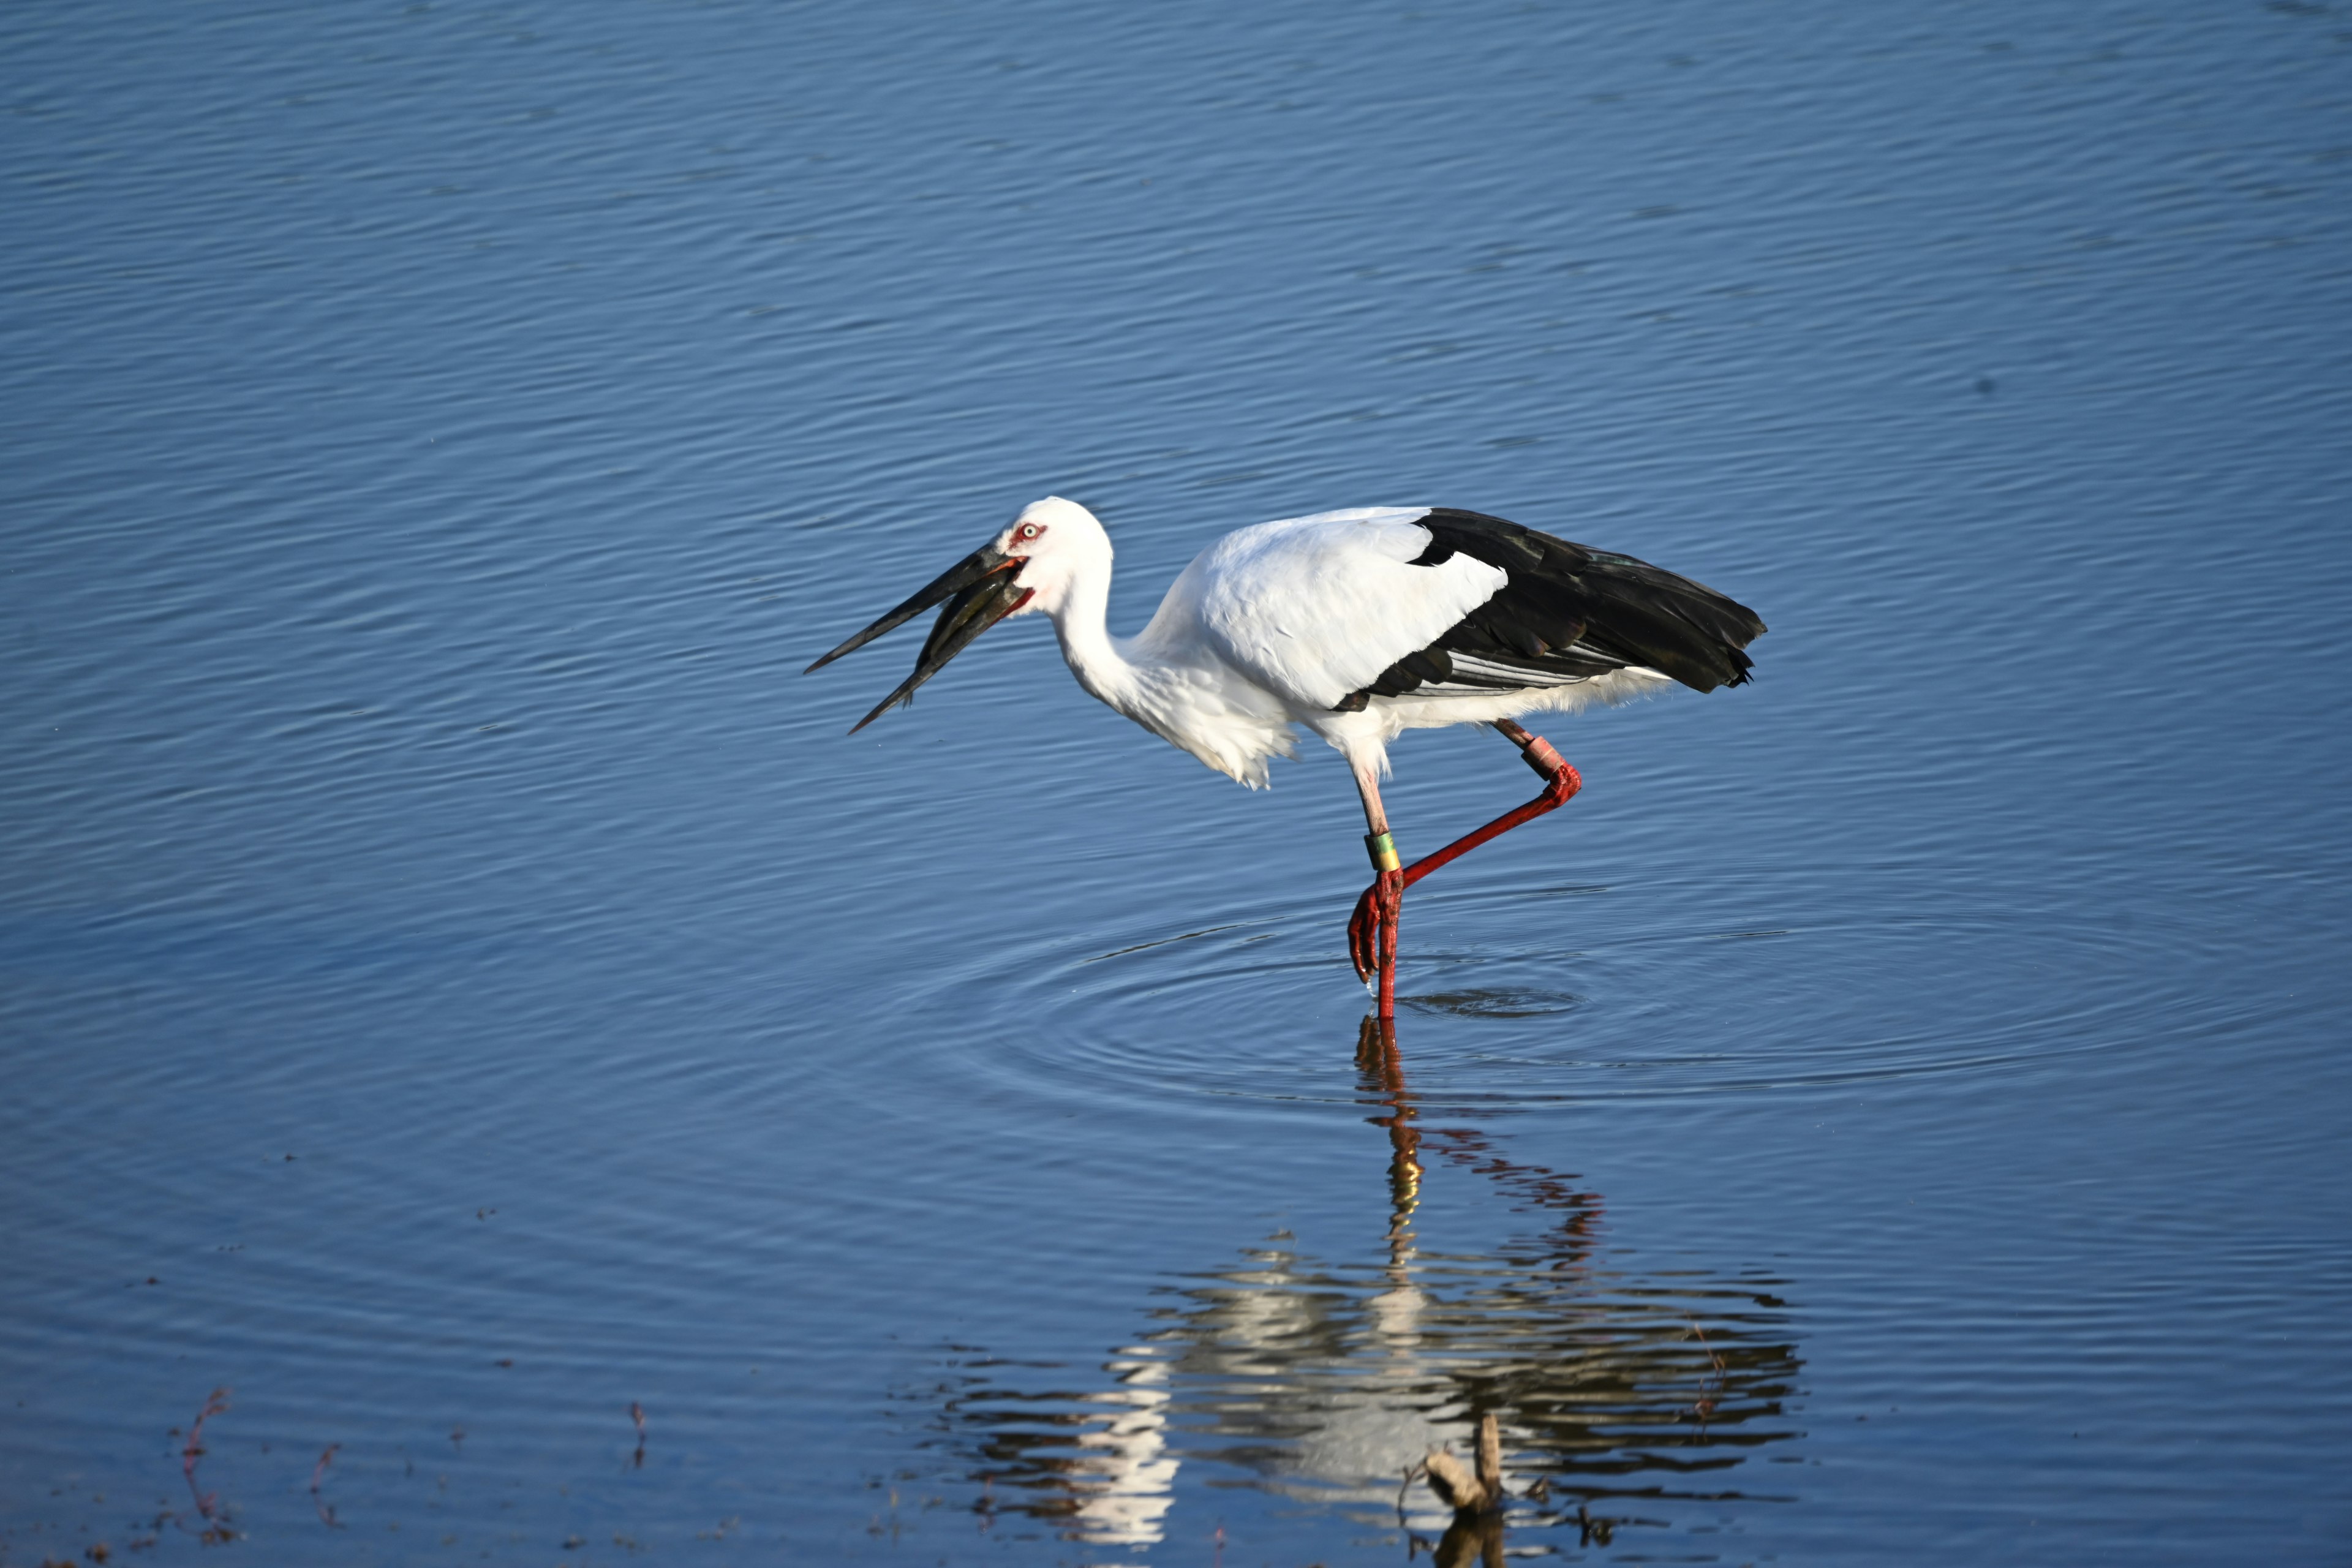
[{"xmin": 804, "ymin": 496, "xmax": 1110, "ymax": 736}]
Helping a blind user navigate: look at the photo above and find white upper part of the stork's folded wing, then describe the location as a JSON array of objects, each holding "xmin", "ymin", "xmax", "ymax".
[{"xmin": 1171, "ymin": 505, "xmax": 1506, "ymax": 707}]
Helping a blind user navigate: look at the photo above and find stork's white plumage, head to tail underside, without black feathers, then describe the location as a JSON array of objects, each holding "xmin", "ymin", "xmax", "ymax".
[{"xmin": 1000, "ymin": 496, "xmax": 1672, "ymax": 790}]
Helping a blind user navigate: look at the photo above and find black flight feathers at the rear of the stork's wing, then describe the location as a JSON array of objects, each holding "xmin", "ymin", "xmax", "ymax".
[{"xmin": 1341, "ymin": 508, "xmax": 1764, "ymax": 710}]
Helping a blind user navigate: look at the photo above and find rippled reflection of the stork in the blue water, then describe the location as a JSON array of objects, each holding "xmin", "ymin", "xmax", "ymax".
[{"xmin": 926, "ymin": 1018, "xmax": 1797, "ymax": 1563}]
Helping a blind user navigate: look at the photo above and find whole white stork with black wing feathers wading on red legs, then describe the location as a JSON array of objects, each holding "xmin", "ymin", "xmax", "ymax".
[{"xmin": 809, "ymin": 496, "xmax": 1764, "ymax": 1018}]
